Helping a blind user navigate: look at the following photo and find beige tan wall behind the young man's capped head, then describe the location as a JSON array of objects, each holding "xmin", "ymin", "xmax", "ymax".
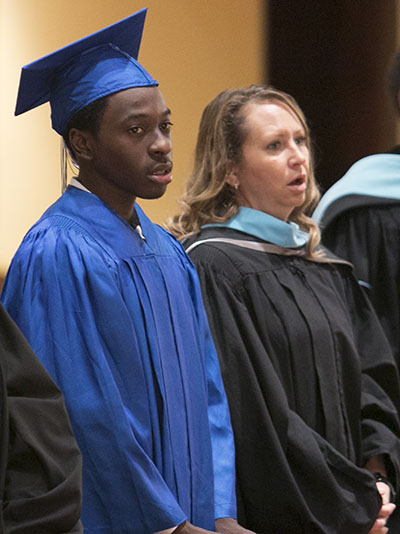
[{"xmin": 0, "ymin": 0, "xmax": 265, "ymax": 272}]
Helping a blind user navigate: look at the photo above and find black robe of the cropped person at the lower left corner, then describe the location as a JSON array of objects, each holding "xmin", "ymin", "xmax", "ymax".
[{"xmin": 0, "ymin": 305, "xmax": 83, "ymax": 534}]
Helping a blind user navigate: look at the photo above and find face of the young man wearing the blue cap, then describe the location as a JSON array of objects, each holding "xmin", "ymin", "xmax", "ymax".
[{"xmin": 92, "ymin": 87, "xmax": 172, "ymax": 203}]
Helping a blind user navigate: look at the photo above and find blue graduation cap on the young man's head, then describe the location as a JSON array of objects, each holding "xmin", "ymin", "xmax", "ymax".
[{"xmin": 15, "ymin": 9, "xmax": 158, "ymax": 135}]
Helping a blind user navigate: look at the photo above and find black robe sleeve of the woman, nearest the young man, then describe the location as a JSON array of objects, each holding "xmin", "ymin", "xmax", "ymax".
[{"xmin": 191, "ymin": 250, "xmax": 380, "ymax": 534}]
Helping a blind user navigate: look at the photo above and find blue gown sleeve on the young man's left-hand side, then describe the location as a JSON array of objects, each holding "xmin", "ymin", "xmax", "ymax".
[{"xmin": 2, "ymin": 228, "xmax": 186, "ymax": 533}]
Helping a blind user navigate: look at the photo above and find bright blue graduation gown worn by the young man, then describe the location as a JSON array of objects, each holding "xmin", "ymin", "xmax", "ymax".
[{"xmin": 1, "ymin": 187, "xmax": 235, "ymax": 534}]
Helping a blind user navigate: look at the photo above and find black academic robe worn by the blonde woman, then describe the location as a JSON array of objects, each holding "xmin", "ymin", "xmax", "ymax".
[{"xmin": 185, "ymin": 228, "xmax": 400, "ymax": 534}]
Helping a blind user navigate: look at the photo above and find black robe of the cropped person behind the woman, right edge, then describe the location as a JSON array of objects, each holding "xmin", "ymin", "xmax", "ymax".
[{"xmin": 322, "ymin": 196, "xmax": 400, "ymax": 367}]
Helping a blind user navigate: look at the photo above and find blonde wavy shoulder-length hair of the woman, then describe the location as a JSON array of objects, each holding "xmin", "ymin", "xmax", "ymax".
[{"xmin": 165, "ymin": 85, "xmax": 321, "ymax": 257}]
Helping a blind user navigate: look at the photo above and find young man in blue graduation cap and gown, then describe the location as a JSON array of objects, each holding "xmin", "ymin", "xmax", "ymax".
[{"xmin": 2, "ymin": 10, "xmax": 253, "ymax": 534}]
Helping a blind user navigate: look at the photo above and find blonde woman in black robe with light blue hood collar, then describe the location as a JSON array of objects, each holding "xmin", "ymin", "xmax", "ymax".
[{"xmin": 168, "ymin": 86, "xmax": 400, "ymax": 534}]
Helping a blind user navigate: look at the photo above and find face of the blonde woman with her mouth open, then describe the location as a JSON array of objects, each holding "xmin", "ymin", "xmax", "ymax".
[{"xmin": 226, "ymin": 100, "xmax": 310, "ymax": 221}]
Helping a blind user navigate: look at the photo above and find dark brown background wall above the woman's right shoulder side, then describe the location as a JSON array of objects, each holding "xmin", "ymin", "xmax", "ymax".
[{"xmin": 267, "ymin": 0, "xmax": 396, "ymax": 190}]
